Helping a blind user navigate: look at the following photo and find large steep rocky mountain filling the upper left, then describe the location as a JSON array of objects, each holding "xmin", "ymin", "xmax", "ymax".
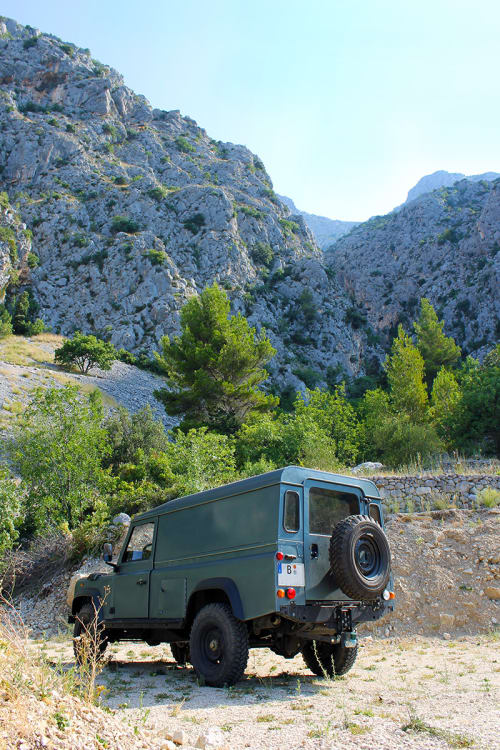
[{"xmin": 0, "ymin": 19, "xmax": 376, "ymax": 394}]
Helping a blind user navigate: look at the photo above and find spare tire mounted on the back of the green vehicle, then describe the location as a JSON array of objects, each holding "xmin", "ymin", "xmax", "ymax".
[{"xmin": 330, "ymin": 516, "xmax": 391, "ymax": 601}]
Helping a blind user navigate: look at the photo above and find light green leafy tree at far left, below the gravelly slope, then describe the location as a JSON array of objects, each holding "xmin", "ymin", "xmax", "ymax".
[{"xmin": 10, "ymin": 385, "xmax": 108, "ymax": 533}]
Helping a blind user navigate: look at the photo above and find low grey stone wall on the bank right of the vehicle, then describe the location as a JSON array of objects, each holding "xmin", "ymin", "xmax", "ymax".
[{"xmin": 370, "ymin": 473, "xmax": 500, "ymax": 511}]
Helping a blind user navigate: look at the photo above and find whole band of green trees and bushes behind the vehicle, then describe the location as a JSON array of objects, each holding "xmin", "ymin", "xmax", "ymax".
[{"xmin": 0, "ymin": 286, "xmax": 500, "ymax": 576}]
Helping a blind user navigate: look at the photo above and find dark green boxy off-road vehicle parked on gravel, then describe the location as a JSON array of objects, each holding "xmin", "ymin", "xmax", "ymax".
[{"xmin": 69, "ymin": 466, "xmax": 394, "ymax": 686}]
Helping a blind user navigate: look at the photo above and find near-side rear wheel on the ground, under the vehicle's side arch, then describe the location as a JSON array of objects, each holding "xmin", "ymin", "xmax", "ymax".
[{"xmin": 189, "ymin": 603, "xmax": 248, "ymax": 687}]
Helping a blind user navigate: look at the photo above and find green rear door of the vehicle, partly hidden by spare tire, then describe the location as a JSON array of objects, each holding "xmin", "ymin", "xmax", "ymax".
[{"xmin": 304, "ymin": 479, "xmax": 361, "ymax": 602}]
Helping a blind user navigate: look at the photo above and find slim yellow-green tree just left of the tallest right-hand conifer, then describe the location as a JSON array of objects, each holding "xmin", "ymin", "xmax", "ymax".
[{"xmin": 384, "ymin": 325, "xmax": 428, "ymax": 423}]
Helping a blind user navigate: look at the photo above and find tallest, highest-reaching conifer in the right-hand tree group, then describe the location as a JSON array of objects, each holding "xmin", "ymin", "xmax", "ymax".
[{"xmin": 413, "ymin": 297, "xmax": 461, "ymax": 386}]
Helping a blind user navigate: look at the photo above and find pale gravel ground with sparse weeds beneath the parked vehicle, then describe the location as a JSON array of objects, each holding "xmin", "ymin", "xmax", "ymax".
[{"xmin": 43, "ymin": 635, "xmax": 500, "ymax": 750}]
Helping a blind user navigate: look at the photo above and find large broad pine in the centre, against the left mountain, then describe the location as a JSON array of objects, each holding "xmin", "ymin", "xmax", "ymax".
[{"xmin": 155, "ymin": 284, "xmax": 278, "ymax": 433}]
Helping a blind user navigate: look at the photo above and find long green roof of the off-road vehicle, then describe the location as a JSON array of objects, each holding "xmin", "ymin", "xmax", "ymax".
[{"xmin": 133, "ymin": 466, "xmax": 380, "ymax": 523}]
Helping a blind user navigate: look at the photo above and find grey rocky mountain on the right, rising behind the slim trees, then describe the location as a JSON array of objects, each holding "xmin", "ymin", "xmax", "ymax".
[{"xmin": 326, "ymin": 179, "xmax": 500, "ymax": 357}]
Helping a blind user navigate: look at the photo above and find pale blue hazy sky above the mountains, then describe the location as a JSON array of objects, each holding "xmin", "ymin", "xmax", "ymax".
[{"xmin": 0, "ymin": 0, "xmax": 500, "ymax": 220}]
